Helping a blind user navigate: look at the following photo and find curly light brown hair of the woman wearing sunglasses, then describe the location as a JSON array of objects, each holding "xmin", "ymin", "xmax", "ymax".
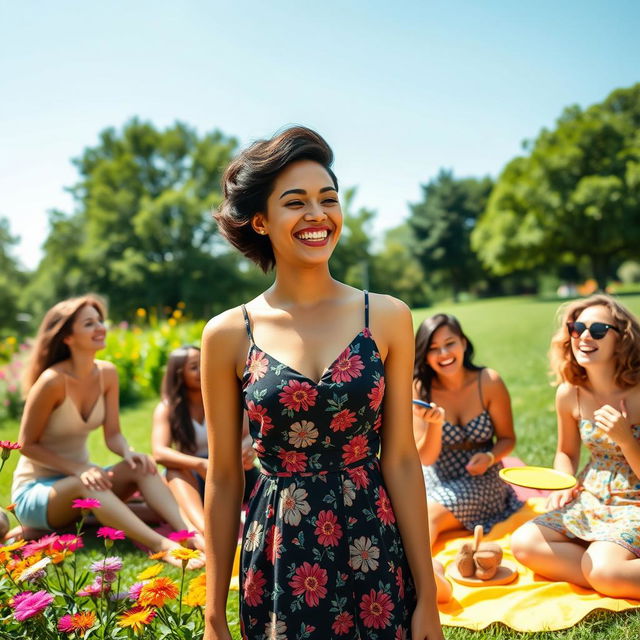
[{"xmin": 549, "ymin": 294, "xmax": 640, "ymax": 389}]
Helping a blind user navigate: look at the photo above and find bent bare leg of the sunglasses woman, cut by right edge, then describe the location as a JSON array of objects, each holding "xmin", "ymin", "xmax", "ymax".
[{"xmin": 582, "ymin": 541, "xmax": 640, "ymax": 600}]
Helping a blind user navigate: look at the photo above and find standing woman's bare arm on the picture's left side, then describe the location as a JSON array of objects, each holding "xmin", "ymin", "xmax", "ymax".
[{"xmin": 201, "ymin": 309, "xmax": 246, "ymax": 640}]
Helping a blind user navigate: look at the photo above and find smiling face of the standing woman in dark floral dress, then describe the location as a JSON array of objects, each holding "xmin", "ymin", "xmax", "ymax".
[{"xmin": 252, "ymin": 160, "xmax": 342, "ymax": 265}]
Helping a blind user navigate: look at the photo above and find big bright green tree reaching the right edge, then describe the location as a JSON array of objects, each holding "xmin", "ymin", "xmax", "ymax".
[{"xmin": 472, "ymin": 84, "xmax": 640, "ymax": 289}]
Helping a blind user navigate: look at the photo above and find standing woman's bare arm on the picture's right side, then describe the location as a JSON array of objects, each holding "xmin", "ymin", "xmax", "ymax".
[{"xmin": 372, "ymin": 296, "xmax": 442, "ymax": 640}]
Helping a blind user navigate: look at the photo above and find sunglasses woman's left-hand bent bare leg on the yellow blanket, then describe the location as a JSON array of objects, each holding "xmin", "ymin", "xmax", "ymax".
[{"xmin": 511, "ymin": 522, "xmax": 590, "ymax": 587}]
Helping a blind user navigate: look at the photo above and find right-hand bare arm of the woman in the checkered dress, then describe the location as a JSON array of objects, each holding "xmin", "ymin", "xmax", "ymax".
[{"xmin": 466, "ymin": 369, "xmax": 516, "ymax": 476}]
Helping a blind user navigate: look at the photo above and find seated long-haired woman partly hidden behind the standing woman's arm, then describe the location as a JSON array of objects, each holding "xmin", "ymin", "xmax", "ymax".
[{"xmin": 151, "ymin": 345, "xmax": 259, "ymax": 533}]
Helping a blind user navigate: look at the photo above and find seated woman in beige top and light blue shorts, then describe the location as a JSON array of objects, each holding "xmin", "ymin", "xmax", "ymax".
[{"xmin": 12, "ymin": 296, "xmax": 203, "ymax": 568}]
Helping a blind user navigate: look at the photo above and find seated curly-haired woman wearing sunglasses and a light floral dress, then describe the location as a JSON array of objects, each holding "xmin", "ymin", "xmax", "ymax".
[{"xmin": 511, "ymin": 295, "xmax": 640, "ymax": 599}]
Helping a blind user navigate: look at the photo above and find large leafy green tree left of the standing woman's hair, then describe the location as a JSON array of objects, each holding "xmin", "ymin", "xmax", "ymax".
[{"xmin": 22, "ymin": 119, "xmax": 263, "ymax": 317}]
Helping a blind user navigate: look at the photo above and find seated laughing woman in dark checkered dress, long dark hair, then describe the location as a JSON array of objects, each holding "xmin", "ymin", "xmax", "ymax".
[{"xmin": 413, "ymin": 313, "xmax": 522, "ymax": 543}]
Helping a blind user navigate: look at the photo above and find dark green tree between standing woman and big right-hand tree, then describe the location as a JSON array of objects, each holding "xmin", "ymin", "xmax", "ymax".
[{"xmin": 409, "ymin": 170, "xmax": 493, "ymax": 298}]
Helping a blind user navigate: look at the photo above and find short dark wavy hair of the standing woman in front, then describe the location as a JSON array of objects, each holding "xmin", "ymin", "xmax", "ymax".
[{"xmin": 214, "ymin": 127, "xmax": 338, "ymax": 273}]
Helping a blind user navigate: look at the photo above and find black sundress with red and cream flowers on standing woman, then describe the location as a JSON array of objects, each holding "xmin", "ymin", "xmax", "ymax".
[{"xmin": 240, "ymin": 292, "xmax": 416, "ymax": 640}]
